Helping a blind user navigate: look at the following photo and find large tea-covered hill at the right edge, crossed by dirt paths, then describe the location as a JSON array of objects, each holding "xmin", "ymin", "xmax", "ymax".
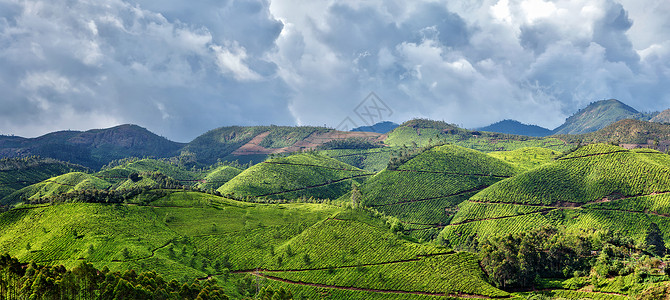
[{"xmin": 441, "ymin": 144, "xmax": 670, "ymax": 245}]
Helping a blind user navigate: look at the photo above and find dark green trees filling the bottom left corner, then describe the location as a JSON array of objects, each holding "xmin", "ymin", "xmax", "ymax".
[{"xmin": 0, "ymin": 254, "xmax": 231, "ymax": 300}]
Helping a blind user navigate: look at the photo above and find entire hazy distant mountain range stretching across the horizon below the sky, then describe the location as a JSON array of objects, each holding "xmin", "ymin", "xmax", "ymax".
[{"xmin": 0, "ymin": 99, "xmax": 670, "ymax": 169}]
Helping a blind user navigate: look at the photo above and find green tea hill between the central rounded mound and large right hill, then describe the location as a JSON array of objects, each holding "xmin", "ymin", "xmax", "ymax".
[{"xmin": 356, "ymin": 145, "xmax": 515, "ymax": 238}]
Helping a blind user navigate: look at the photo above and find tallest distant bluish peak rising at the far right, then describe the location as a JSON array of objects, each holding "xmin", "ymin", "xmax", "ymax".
[{"xmin": 553, "ymin": 99, "xmax": 656, "ymax": 134}]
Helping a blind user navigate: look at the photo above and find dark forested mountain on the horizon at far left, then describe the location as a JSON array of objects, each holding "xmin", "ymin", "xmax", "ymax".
[{"xmin": 0, "ymin": 124, "xmax": 183, "ymax": 169}]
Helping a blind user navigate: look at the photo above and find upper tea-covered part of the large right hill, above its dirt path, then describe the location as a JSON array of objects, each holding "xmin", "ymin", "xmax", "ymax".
[{"xmin": 472, "ymin": 144, "xmax": 670, "ymax": 205}]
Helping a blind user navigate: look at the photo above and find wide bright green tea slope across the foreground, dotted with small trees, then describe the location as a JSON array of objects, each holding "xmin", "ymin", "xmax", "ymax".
[{"xmin": 0, "ymin": 192, "xmax": 508, "ymax": 299}]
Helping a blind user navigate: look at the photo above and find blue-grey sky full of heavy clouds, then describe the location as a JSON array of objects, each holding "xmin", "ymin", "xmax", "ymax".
[{"xmin": 0, "ymin": 0, "xmax": 670, "ymax": 142}]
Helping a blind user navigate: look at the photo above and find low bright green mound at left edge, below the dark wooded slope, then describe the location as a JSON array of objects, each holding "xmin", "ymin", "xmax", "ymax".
[{"xmin": 2, "ymin": 172, "xmax": 111, "ymax": 205}]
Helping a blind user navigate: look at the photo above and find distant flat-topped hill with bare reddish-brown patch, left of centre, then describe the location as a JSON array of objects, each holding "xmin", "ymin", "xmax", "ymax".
[{"xmin": 184, "ymin": 126, "xmax": 381, "ymax": 165}]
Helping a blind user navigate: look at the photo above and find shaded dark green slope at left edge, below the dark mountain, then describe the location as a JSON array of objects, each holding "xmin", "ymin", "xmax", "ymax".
[{"xmin": 0, "ymin": 157, "xmax": 86, "ymax": 199}]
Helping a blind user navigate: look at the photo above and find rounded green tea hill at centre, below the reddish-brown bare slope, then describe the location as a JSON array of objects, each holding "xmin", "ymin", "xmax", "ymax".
[{"xmin": 218, "ymin": 153, "xmax": 370, "ymax": 199}]
